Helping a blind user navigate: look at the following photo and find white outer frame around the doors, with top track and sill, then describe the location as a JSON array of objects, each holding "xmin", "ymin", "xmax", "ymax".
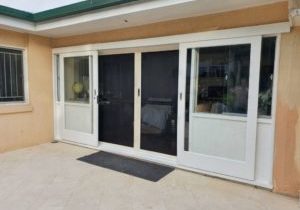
[{"xmin": 52, "ymin": 22, "xmax": 290, "ymax": 189}]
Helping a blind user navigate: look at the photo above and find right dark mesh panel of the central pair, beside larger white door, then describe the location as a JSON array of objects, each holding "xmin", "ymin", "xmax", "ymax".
[{"xmin": 141, "ymin": 51, "xmax": 178, "ymax": 155}]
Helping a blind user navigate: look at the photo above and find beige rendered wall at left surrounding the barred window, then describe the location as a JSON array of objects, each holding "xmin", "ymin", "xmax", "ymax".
[{"xmin": 0, "ymin": 30, "xmax": 53, "ymax": 153}]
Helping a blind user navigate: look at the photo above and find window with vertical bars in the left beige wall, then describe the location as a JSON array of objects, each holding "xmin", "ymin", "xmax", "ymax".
[{"xmin": 0, "ymin": 48, "xmax": 25, "ymax": 102}]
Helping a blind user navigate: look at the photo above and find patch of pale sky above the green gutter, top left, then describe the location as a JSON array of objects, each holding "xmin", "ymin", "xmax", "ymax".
[{"xmin": 0, "ymin": 0, "xmax": 84, "ymax": 13}]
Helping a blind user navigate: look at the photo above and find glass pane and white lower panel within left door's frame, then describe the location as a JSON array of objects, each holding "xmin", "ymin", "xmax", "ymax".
[{"xmin": 64, "ymin": 56, "xmax": 93, "ymax": 133}]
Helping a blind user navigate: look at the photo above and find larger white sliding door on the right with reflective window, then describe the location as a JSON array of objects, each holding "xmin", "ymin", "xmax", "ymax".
[{"xmin": 178, "ymin": 37, "xmax": 261, "ymax": 180}]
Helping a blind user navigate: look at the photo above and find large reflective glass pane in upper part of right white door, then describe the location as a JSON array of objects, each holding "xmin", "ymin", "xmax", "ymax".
[{"xmin": 194, "ymin": 44, "xmax": 251, "ymax": 115}]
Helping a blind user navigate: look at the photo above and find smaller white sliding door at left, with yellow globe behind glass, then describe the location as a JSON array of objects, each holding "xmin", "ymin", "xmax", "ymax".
[{"xmin": 60, "ymin": 52, "xmax": 98, "ymax": 146}]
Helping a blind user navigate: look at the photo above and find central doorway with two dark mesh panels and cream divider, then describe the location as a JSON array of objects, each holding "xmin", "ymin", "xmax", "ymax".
[{"xmin": 98, "ymin": 50, "xmax": 179, "ymax": 155}]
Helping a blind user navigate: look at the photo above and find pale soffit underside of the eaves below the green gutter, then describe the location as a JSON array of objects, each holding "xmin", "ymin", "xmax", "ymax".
[{"xmin": 0, "ymin": 0, "xmax": 286, "ymax": 37}]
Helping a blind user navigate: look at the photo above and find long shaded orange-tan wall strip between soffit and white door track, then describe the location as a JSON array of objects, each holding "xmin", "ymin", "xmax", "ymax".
[{"xmin": 52, "ymin": 1, "xmax": 288, "ymax": 47}]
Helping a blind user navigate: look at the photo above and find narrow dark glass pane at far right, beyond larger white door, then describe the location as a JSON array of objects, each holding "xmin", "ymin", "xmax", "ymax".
[{"xmin": 258, "ymin": 37, "xmax": 276, "ymax": 118}]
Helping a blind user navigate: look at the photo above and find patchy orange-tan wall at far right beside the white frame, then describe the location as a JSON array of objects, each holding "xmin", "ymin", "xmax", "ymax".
[{"xmin": 274, "ymin": 27, "xmax": 300, "ymax": 196}]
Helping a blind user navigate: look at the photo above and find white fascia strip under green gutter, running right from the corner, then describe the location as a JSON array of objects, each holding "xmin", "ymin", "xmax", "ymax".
[{"xmin": 36, "ymin": 0, "xmax": 196, "ymax": 32}]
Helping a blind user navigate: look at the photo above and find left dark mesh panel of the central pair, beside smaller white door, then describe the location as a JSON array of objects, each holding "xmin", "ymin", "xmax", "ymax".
[{"xmin": 98, "ymin": 54, "xmax": 134, "ymax": 147}]
